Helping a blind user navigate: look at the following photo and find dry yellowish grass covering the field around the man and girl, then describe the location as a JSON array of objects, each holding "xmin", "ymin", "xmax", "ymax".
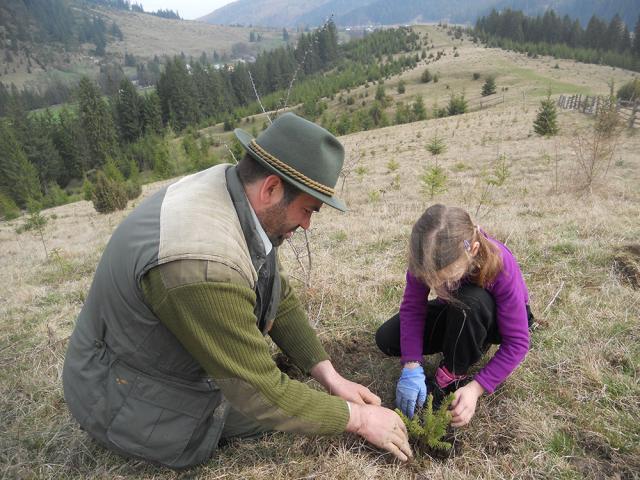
[{"xmin": 0, "ymin": 31, "xmax": 640, "ymax": 479}]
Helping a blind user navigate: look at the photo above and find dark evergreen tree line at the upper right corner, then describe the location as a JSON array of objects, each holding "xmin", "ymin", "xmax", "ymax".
[{"xmin": 474, "ymin": 9, "xmax": 640, "ymax": 71}]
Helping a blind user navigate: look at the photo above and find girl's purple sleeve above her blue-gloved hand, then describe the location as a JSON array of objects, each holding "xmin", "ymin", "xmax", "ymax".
[{"xmin": 400, "ymin": 271, "xmax": 429, "ymax": 363}]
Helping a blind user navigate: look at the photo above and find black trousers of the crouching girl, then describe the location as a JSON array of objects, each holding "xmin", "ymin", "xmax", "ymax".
[{"xmin": 376, "ymin": 285, "xmax": 500, "ymax": 375}]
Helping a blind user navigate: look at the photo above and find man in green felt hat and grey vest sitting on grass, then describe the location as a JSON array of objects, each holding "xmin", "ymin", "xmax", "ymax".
[{"xmin": 63, "ymin": 113, "xmax": 411, "ymax": 468}]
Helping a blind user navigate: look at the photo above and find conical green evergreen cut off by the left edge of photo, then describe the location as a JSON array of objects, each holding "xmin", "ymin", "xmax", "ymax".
[{"xmin": 0, "ymin": 120, "xmax": 42, "ymax": 208}]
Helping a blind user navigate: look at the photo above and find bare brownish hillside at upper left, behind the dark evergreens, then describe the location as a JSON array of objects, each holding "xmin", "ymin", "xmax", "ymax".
[{"xmin": 0, "ymin": 0, "xmax": 283, "ymax": 90}]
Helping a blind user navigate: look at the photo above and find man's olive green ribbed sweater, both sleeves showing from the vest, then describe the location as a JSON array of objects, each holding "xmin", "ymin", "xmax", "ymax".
[{"xmin": 142, "ymin": 260, "xmax": 349, "ymax": 434}]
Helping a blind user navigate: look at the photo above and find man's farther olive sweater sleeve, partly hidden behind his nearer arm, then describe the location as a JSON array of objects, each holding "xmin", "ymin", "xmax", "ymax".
[{"xmin": 269, "ymin": 274, "xmax": 329, "ymax": 373}]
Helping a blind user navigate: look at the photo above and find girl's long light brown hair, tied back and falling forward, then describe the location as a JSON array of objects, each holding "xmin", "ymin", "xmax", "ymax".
[{"xmin": 409, "ymin": 204, "xmax": 502, "ymax": 300}]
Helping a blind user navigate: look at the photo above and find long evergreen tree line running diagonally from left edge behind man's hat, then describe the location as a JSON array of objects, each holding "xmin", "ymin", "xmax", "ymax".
[{"xmin": 0, "ymin": 22, "xmax": 417, "ymax": 217}]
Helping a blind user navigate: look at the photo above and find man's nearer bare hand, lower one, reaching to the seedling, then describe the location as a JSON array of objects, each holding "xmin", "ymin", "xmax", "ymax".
[{"xmin": 347, "ymin": 403, "xmax": 413, "ymax": 462}]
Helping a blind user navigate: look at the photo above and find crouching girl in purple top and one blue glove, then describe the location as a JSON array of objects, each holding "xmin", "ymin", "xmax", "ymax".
[{"xmin": 376, "ymin": 205, "xmax": 533, "ymax": 427}]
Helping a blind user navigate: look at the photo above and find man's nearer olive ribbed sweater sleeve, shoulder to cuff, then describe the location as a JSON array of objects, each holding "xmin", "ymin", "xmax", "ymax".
[{"xmin": 143, "ymin": 268, "xmax": 349, "ymax": 434}]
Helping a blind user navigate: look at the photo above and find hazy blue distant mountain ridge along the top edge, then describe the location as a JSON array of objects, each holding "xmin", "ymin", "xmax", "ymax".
[{"xmin": 199, "ymin": 0, "xmax": 640, "ymax": 28}]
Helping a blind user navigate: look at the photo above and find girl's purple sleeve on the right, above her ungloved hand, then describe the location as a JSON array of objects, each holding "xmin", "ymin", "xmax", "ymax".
[{"xmin": 475, "ymin": 245, "xmax": 529, "ymax": 393}]
